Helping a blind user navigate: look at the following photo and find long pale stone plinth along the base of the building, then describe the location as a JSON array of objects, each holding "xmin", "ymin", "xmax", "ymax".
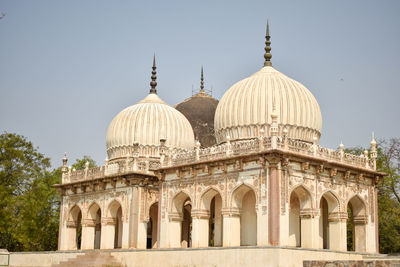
[{"xmin": 10, "ymin": 247, "xmax": 378, "ymax": 267}]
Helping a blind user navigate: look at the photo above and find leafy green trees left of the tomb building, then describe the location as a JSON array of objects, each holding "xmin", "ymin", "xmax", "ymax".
[{"xmin": 0, "ymin": 133, "xmax": 96, "ymax": 251}]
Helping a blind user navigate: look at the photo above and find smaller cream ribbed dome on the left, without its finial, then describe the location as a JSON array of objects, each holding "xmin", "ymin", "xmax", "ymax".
[{"xmin": 107, "ymin": 93, "xmax": 194, "ymax": 160}]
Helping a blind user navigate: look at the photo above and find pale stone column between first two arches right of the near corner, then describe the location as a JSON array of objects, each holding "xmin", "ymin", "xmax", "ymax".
[{"xmin": 300, "ymin": 209, "xmax": 319, "ymax": 248}]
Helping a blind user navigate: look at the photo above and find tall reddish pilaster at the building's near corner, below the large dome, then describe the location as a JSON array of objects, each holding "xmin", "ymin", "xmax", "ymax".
[{"xmin": 267, "ymin": 157, "xmax": 280, "ymax": 246}]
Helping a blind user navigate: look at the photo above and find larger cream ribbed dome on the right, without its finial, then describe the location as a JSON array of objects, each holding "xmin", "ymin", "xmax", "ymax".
[{"xmin": 214, "ymin": 66, "xmax": 322, "ymax": 143}]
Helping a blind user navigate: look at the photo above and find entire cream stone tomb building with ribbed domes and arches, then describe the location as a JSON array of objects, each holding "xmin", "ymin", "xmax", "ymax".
[{"xmin": 56, "ymin": 24, "xmax": 383, "ymax": 255}]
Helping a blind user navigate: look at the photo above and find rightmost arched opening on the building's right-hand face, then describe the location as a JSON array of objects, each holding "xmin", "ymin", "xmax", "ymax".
[{"xmin": 347, "ymin": 196, "xmax": 368, "ymax": 252}]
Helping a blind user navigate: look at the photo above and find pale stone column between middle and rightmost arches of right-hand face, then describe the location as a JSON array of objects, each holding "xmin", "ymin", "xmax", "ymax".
[{"xmin": 328, "ymin": 212, "xmax": 347, "ymax": 251}]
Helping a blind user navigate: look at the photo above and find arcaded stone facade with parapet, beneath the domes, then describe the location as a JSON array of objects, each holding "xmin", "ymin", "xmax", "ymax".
[{"xmin": 57, "ymin": 136, "xmax": 383, "ymax": 252}]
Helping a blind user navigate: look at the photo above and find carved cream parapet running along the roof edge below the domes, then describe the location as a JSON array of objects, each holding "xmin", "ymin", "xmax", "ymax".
[{"xmin": 62, "ymin": 136, "xmax": 376, "ymax": 184}]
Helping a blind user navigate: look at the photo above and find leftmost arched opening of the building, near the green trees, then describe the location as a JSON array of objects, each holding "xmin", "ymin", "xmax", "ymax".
[{"xmin": 67, "ymin": 205, "xmax": 82, "ymax": 250}]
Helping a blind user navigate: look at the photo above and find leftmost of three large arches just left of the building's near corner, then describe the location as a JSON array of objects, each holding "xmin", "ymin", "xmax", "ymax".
[{"xmin": 170, "ymin": 192, "xmax": 192, "ymax": 248}]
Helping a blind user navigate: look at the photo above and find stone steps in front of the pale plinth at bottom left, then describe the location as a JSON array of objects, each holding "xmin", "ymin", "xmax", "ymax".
[{"xmin": 52, "ymin": 252, "xmax": 124, "ymax": 267}]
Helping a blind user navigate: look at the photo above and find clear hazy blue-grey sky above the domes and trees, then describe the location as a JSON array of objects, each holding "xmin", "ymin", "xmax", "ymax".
[{"xmin": 0, "ymin": 0, "xmax": 400, "ymax": 166}]
